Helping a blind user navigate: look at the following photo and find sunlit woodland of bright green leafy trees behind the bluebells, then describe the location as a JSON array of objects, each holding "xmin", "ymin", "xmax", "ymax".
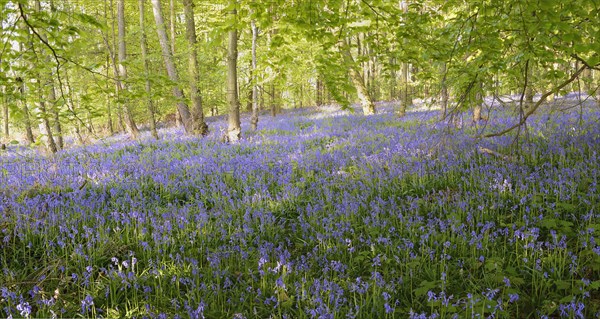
[{"xmin": 0, "ymin": 0, "xmax": 600, "ymax": 152}]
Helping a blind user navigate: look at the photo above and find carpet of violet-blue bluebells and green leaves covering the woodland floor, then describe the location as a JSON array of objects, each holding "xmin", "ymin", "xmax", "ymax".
[{"xmin": 0, "ymin": 99, "xmax": 600, "ymax": 319}]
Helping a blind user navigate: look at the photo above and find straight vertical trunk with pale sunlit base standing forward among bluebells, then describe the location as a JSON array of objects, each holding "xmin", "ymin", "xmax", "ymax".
[{"xmin": 227, "ymin": 0, "xmax": 242, "ymax": 143}]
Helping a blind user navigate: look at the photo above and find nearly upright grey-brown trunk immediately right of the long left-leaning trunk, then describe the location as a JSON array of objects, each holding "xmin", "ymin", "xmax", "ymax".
[{"xmin": 183, "ymin": 0, "xmax": 208, "ymax": 135}]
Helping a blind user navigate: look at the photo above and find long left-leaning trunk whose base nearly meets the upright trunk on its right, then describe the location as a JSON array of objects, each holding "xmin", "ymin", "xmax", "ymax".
[{"xmin": 152, "ymin": 0, "xmax": 194, "ymax": 134}]
